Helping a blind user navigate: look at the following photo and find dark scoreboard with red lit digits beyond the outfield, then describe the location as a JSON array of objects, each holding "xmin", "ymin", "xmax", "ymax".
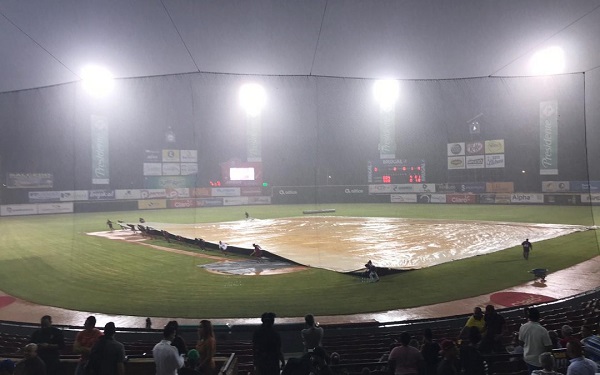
[{"xmin": 367, "ymin": 159, "xmax": 427, "ymax": 184}]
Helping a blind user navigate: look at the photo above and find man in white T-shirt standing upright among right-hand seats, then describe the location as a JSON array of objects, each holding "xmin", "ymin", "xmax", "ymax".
[{"xmin": 519, "ymin": 307, "xmax": 552, "ymax": 373}]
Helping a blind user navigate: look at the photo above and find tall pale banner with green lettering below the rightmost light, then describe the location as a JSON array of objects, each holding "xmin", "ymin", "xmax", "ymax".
[{"xmin": 540, "ymin": 100, "xmax": 558, "ymax": 175}]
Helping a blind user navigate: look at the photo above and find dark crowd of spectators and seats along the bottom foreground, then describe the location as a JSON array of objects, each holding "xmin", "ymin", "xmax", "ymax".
[{"xmin": 0, "ymin": 300, "xmax": 600, "ymax": 375}]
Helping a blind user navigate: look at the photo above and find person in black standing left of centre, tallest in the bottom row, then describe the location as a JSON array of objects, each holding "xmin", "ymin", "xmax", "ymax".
[{"xmin": 252, "ymin": 312, "xmax": 285, "ymax": 375}]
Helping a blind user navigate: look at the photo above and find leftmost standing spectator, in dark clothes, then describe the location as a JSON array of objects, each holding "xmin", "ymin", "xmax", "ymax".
[{"xmin": 30, "ymin": 315, "xmax": 65, "ymax": 375}]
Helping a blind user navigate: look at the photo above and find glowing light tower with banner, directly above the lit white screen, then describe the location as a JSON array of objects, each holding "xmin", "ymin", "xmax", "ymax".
[{"xmin": 240, "ymin": 83, "xmax": 267, "ymax": 162}]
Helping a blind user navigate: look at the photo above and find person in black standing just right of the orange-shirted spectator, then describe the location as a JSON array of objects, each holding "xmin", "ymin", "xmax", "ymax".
[{"xmin": 86, "ymin": 322, "xmax": 126, "ymax": 375}]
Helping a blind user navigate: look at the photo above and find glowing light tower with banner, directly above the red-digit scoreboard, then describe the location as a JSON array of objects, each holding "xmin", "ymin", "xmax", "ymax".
[{"xmin": 373, "ymin": 79, "xmax": 400, "ymax": 159}]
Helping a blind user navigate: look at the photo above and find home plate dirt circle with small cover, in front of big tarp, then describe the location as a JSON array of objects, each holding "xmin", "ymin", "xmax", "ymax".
[{"xmin": 198, "ymin": 258, "xmax": 306, "ymax": 275}]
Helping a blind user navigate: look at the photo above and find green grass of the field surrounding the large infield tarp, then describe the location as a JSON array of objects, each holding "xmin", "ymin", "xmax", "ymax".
[{"xmin": 0, "ymin": 204, "xmax": 600, "ymax": 318}]
